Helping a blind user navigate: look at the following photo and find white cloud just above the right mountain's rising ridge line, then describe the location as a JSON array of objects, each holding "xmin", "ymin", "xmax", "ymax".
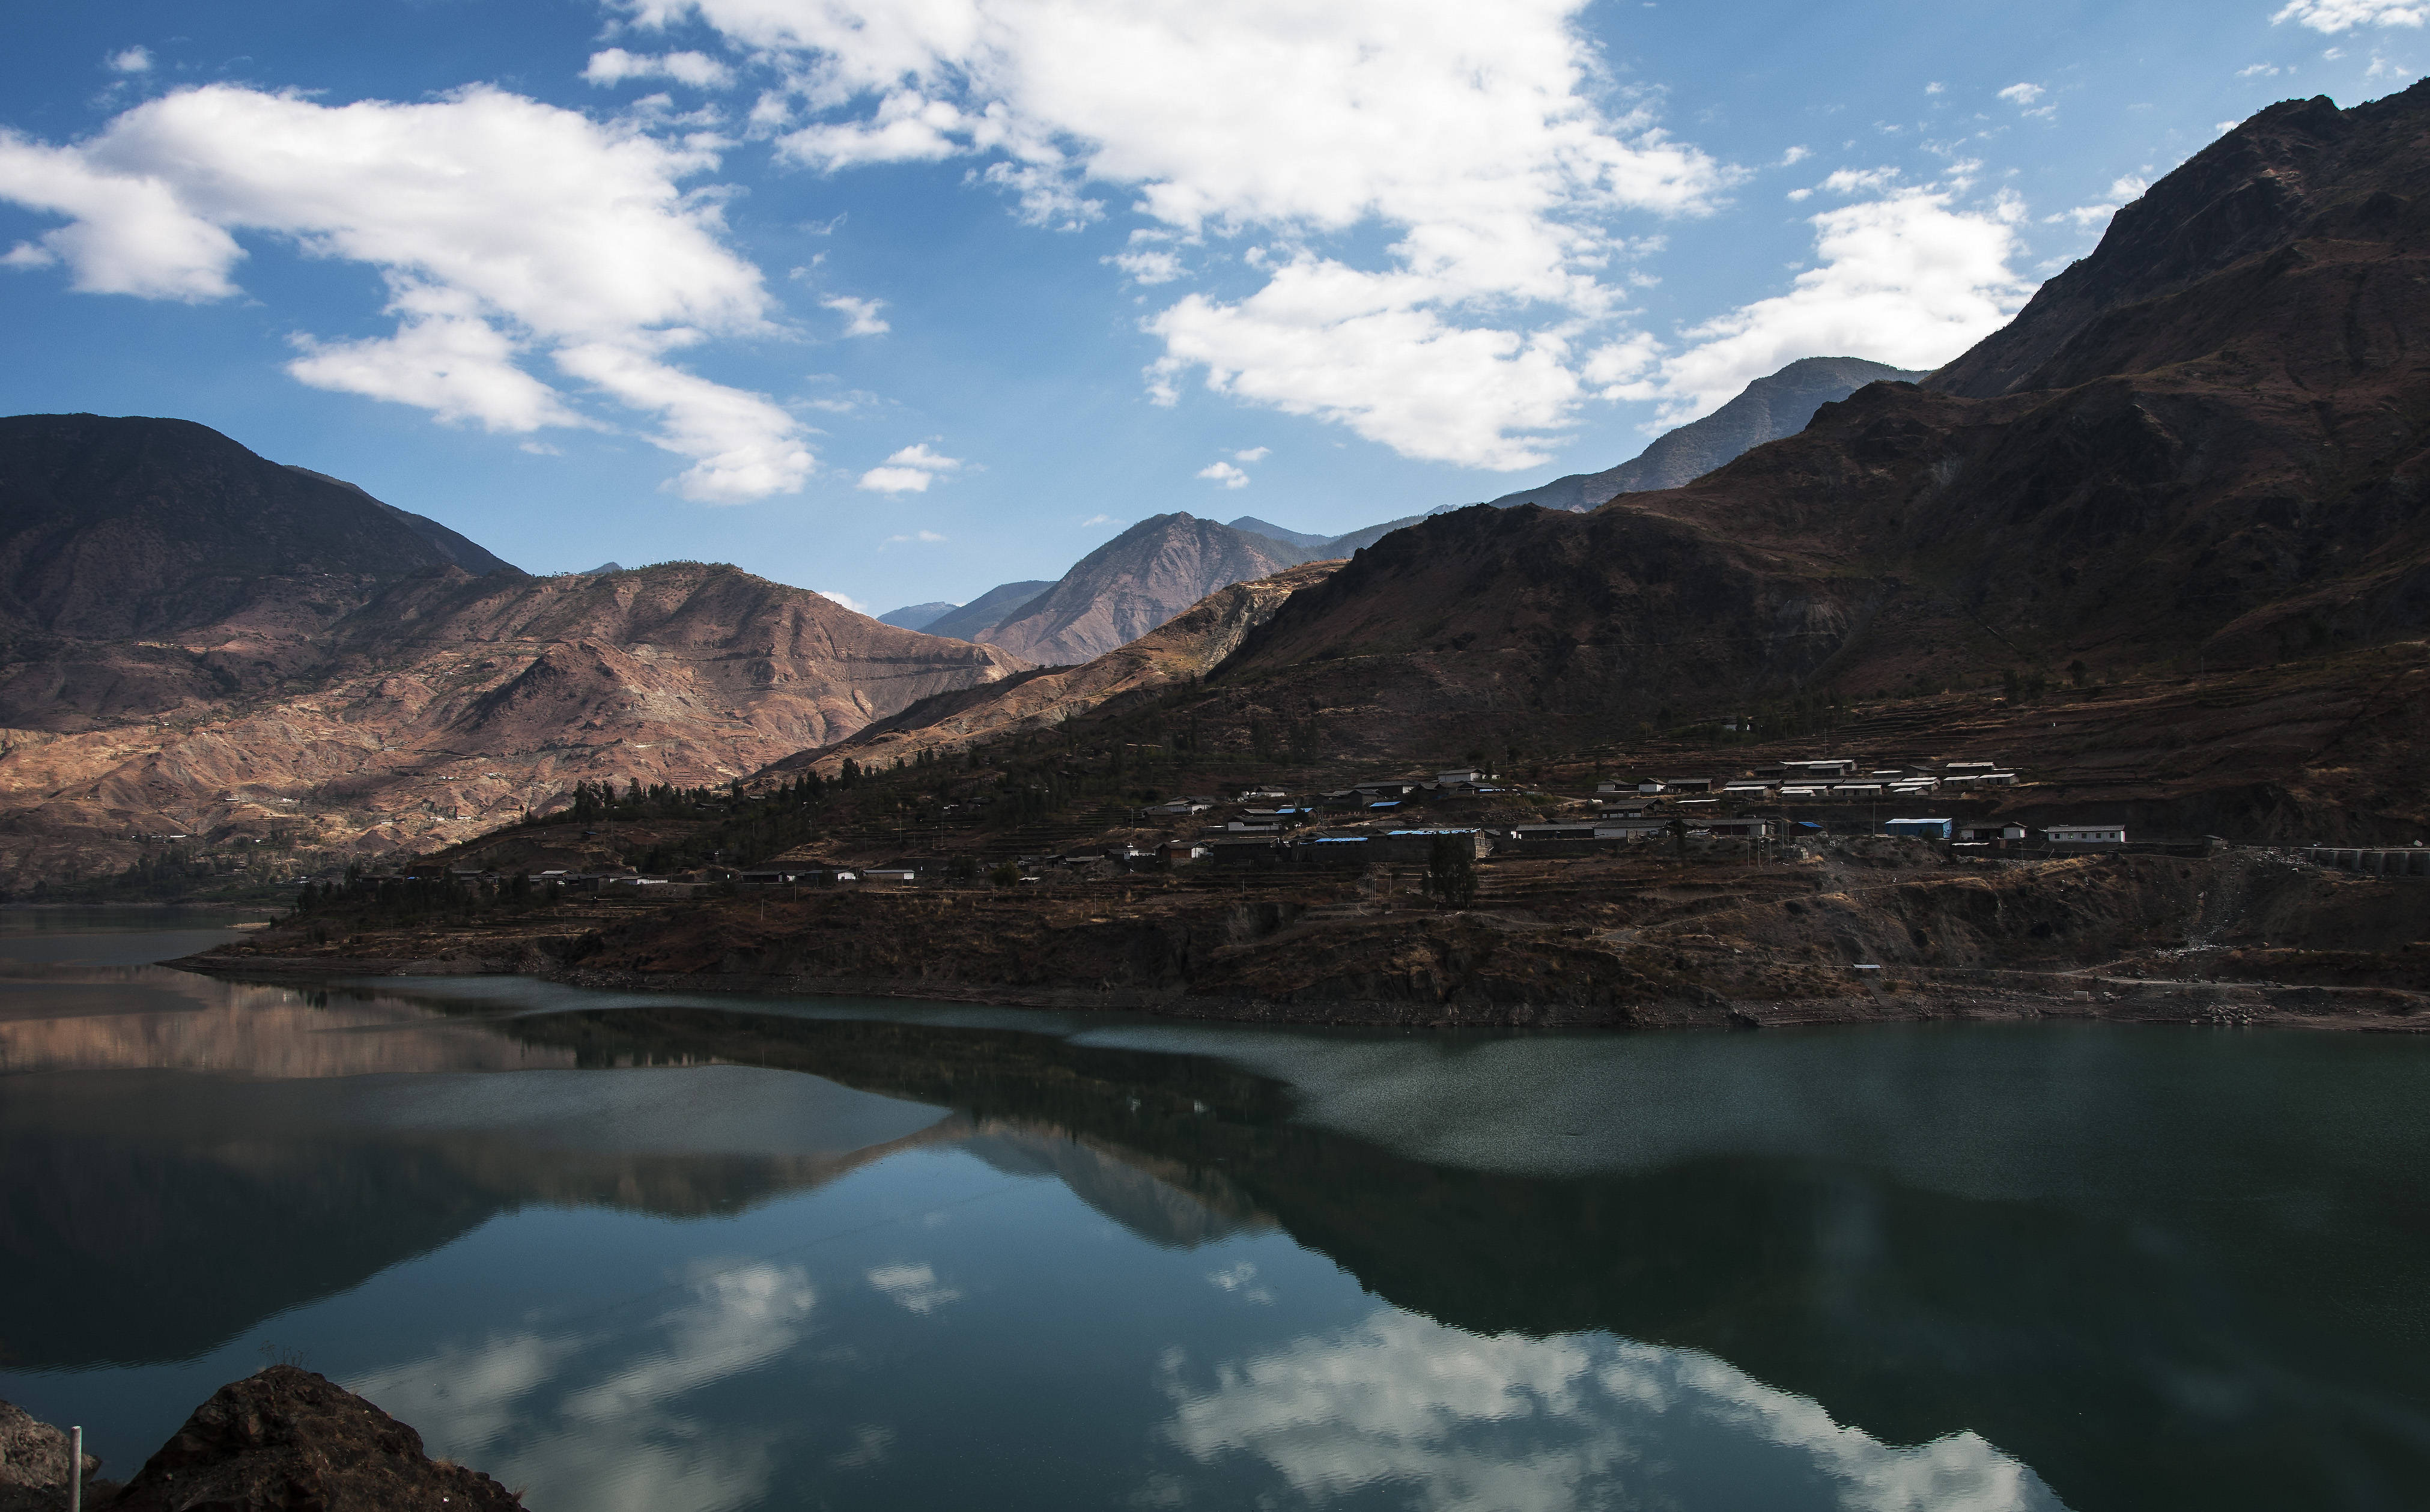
[{"xmin": 1589, "ymin": 175, "xmax": 2034, "ymax": 423}]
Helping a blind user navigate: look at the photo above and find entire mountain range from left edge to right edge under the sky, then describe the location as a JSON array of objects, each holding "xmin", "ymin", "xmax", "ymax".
[{"xmin": 0, "ymin": 85, "xmax": 2430, "ymax": 878}]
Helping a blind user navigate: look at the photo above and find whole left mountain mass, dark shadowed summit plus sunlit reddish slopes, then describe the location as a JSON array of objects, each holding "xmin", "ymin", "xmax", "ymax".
[{"xmin": 0, "ymin": 416, "xmax": 1023, "ymax": 882}]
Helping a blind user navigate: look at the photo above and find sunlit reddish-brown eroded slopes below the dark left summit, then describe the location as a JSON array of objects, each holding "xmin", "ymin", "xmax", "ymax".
[{"xmin": 0, "ymin": 564, "xmax": 1021, "ymax": 882}]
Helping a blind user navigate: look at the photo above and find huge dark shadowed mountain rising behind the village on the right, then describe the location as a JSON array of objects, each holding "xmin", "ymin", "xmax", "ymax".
[{"xmin": 1225, "ymin": 88, "xmax": 2430, "ymax": 758}]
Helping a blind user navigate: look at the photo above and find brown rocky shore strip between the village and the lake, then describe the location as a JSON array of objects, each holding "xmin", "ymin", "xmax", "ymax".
[{"xmin": 175, "ymin": 841, "xmax": 2430, "ymax": 1031}]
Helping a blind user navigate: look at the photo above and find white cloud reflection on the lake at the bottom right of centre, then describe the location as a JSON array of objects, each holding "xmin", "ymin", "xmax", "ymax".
[{"xmin": 1164, "ymin": 1308, "xmax": 2061, "ymax": 1512}]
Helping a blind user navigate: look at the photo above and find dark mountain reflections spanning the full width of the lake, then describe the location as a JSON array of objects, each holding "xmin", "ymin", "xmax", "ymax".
[{"xmin": 0, "ymin": 1004, "xmax": 2425, "ymax": 1507}]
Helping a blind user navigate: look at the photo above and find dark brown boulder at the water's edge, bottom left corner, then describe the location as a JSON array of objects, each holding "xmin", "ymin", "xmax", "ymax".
[{"xmin": 107, "ymin": 1366, "xmax": 523, "ymax": 1512}]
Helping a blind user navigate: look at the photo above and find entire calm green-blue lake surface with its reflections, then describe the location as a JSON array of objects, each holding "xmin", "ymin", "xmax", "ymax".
[{"xmin": 0, "ymin": 911, "xmax": 2430, "ymax": 1512}]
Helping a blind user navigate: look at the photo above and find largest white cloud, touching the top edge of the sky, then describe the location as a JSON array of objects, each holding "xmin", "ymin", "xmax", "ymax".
[{"xmin": 625, "ymin": 0, "xmax": 1735, "ymax": 467}]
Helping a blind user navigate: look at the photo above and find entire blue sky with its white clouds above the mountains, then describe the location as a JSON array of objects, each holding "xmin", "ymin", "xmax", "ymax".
[{"xmin": 0, "ymin": 0, "xmax": 2430, "ymax": 610}]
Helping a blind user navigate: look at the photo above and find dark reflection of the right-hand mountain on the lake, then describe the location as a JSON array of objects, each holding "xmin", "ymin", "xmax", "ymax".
[{"xmin": 488, "ymin": 1006, "xmax": 2430, "ymax": 1507}]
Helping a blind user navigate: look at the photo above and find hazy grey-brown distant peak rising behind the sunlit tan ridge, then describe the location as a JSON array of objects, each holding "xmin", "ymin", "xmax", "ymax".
[{"xmin": 982, "ymin": 513, "xmax": 1307, "ymax": 666}]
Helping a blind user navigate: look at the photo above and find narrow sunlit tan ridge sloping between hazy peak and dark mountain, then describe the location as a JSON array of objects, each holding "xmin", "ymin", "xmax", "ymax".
[{"xmin": 777, "ymin": 562, "xmax": 1341, "ymax": 773}]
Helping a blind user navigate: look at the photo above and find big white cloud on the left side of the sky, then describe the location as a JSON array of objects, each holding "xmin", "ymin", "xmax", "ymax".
[{"xmin": 0, "ymin": 85, "xmax": 814, "ymax": 503}]
